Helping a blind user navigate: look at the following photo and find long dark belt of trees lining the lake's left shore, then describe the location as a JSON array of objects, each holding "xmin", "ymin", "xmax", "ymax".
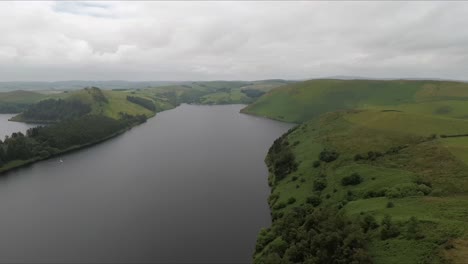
[{"xmin": 0, "ymin": 115, "xmax": 146, "ymax": 166}]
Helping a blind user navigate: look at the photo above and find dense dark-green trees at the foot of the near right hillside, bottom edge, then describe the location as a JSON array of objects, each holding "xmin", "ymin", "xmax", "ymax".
[{"xmin": 254, "ymin": 205, "xmax": 371, "ymax": 264}]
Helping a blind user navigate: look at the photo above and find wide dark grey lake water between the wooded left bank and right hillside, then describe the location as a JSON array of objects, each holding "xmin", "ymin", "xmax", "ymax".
[{"xmin": 0, "ymin": 105, "xmax": 291, "ymax": 263}]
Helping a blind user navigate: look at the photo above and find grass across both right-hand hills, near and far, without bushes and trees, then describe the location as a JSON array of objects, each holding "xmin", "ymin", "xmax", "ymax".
[{"xmin": 249, "ymin": 80, "xmax": 468, "ymax": 263}]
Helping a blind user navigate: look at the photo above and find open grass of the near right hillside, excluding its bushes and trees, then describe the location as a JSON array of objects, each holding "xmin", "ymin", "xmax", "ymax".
[{"xmin": 266, "ymin": 111, "xmax": 468, "ymax": 263}]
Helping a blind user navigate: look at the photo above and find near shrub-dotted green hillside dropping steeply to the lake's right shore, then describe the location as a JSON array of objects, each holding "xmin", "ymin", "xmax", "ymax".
[{"xmin": 255, "ymin": 110, "xmax": 468, "ymax": 263}]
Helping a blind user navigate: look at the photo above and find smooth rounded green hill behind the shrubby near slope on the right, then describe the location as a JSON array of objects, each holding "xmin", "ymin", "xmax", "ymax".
[{"xmin": 243, "ymin": 79, "xmax": 468, "ymax": 123}]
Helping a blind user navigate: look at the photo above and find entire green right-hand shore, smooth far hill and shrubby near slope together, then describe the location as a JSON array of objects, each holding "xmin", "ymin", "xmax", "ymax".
[{"xmin": 246, "ymin": 80, "xmax": 468, "ymax": 263}]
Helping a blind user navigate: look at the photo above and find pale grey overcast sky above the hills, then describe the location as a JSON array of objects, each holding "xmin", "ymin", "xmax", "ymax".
[{"xmin": 0, "ymin": 1, "xmax": 468, "ymax": 81}]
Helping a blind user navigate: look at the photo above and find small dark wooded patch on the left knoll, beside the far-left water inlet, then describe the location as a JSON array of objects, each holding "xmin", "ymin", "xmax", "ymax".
[{"xmin": 21, "ymin": 99, "xmax": 91, "ymax": 122}]
